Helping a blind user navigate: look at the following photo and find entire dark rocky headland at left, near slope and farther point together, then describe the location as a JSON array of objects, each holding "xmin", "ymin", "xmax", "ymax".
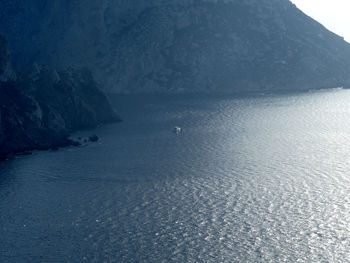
[{"xmin": 0, "ymin": 36, "xmax": 119, "ymax": 159}]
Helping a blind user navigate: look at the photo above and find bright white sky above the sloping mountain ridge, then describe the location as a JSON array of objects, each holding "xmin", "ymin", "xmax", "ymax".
[{"xmin": 291, "ymin": 0, "xmax": 350, "ymax": 42}]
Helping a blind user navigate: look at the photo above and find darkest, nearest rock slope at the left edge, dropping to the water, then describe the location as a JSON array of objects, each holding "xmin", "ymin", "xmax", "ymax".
[{"xmin": 0, "ymin": 83, "xmax": 71, "ymax": 159}]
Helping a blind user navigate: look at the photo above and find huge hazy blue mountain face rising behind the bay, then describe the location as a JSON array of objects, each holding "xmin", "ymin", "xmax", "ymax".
[{"xmin": 0, "ymin": 0, "xmax": 350, "ymax": 93}]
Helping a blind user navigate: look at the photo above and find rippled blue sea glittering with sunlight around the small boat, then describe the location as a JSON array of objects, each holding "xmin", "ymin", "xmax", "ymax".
[{"xmin": 0, "ymin": 90, "xmax": 350, "ymax": 262}]
